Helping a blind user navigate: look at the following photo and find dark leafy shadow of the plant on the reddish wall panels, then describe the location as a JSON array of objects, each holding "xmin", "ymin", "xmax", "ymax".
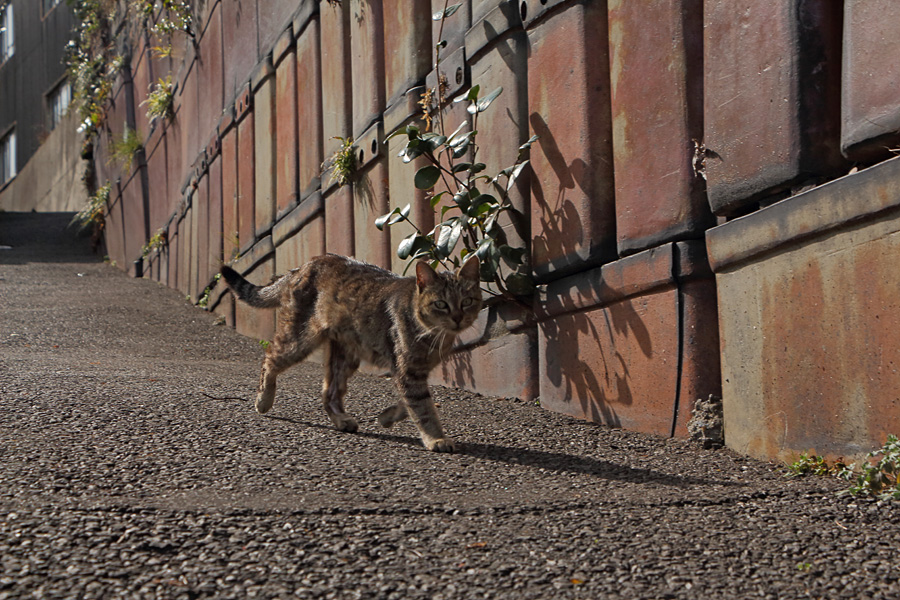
[{"xmin": 530, "ymin": 106, "xmax": 653, "ymax": 427}]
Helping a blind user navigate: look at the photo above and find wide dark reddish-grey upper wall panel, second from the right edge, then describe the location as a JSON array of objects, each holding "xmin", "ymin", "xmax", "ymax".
[{"xmin": 703, "ymin": 0, "xmax": 844, "ymax": 215}]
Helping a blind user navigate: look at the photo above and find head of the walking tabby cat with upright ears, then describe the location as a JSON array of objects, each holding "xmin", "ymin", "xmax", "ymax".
[{"xmin": 416, "ymin": 256, "xmax": 481, "ymax": 335}]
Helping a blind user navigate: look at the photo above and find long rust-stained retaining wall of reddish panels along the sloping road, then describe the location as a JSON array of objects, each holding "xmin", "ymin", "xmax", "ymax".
[{"xmin": 79, "ymin": 0, "xmax": 900, "ymax": 456}]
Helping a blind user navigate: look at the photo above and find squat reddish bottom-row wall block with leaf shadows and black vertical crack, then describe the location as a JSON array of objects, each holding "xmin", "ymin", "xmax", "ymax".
[{"xmin": 538, "ymin": 242, "xmax": 721, "ymax": 435}]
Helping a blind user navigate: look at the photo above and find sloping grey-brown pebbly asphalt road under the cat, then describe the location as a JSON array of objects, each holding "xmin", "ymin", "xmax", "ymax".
[{"xmin": 0, "ymin": 213, "xmax": 900, "ymax": 600}]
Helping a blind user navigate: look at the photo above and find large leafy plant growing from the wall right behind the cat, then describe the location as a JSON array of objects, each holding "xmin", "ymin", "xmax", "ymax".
[{"xmin": 375, "ymin": 2, "xmax": 537, "ymax": 300}]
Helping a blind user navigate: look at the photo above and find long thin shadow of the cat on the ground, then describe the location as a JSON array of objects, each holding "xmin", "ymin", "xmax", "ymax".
[{"xmin": 266, "ymin": 415, "xmax": 745, "ymax": 488}]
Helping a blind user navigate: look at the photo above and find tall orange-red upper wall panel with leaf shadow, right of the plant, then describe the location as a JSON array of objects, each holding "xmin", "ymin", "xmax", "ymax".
[{"xmin": 528, "ymin": 2, "xmax": 616, "ymax": 280}]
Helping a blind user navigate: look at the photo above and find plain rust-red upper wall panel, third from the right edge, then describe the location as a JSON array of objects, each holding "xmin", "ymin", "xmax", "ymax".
[{"xmin": 609, "ymin": 0, "xmax": 712, "ymax": 255}]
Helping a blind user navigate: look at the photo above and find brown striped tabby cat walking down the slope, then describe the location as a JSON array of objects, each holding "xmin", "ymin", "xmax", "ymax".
[{"xmin": 222, "ymin": 254, "xmax": 481, "ymax": 452}]
